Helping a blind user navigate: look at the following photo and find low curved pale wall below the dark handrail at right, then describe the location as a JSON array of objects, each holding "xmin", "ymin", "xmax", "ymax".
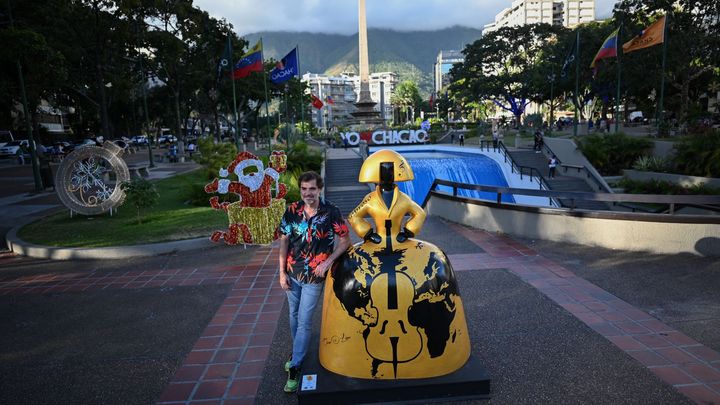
[{"xmin": 425, "ymin": 196, "xmax": 720, "ymax": 256}]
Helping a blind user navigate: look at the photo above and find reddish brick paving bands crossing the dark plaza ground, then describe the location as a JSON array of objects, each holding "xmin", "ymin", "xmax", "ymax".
[{"xmin": 0, "ymin": 224, "xmax": 720, "ymax": 404}]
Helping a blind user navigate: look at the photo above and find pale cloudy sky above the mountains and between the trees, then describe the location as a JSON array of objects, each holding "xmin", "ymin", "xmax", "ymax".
[{"xmin": 194, "ymin": 0, "xmax": 617, "ymax": 36}]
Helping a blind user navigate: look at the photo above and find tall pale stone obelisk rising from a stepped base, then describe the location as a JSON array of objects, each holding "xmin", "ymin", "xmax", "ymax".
[{"xmin": 351, "ymin": 0, "xmax": 382, "ymax": 125}]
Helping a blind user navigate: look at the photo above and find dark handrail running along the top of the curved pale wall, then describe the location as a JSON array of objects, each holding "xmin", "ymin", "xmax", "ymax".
[{"xmin": 422, "ymin": 179, "xmax": 720, "ymax": 214}]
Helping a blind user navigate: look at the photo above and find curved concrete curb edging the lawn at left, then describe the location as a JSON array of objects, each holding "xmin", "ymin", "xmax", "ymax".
[{"xmin": 5, "ymin": 225, "xmax": 217, "ymax": 260}]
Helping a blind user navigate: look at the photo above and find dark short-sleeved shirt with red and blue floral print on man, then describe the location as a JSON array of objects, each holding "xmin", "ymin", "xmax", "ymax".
[{"xmin": 280, "ymin": 199, "xmax": 348, "ymax": 283}]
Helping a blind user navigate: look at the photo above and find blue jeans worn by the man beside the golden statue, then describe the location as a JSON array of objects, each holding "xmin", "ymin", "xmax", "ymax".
[{"xmin": 285, "ymin": 277, "xmax": 323, "ymax": 367}]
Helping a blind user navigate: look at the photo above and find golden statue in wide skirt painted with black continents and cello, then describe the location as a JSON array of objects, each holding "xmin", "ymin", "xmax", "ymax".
[{"xmin": 319, "ymin": 150, "xmax": 470, "ymax": 380}]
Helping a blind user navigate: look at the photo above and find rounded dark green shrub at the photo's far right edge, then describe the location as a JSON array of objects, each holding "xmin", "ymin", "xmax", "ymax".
[{"xmin": 674, "ymin": 130, "xmax": 720, "ymax": 177}]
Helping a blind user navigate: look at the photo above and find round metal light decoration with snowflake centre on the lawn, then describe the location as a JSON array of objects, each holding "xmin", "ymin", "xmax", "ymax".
[{"xmin": 55, "ymin": 141, "xmax": 130, "ymax": 215}]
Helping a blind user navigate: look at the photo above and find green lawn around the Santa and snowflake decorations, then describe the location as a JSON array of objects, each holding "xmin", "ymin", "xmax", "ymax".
[{"xmin": 18, "ymin": 170, "xmax": 228, "ymax": 247}]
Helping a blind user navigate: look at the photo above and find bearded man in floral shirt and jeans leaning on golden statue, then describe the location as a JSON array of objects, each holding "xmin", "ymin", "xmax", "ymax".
[{"xmin": 279, "ymin": 172, "xmax": 350, "ymax": 392}]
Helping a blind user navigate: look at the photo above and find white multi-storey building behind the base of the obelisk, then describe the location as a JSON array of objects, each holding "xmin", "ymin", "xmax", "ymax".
[{"xmin": 301, "ymin": 72, "xmax": 398, "ymax": 130}]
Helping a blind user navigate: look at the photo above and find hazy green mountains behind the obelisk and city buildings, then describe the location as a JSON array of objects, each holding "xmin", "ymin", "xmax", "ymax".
[{"xmin": 245, "ymin": 26, "xmax": 481, "ymax": 96}]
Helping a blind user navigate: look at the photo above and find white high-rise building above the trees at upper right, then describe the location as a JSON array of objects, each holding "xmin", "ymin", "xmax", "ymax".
[{"xmin": 483, "ymin": 0, "xmax": 595, "ymax": 34}]
